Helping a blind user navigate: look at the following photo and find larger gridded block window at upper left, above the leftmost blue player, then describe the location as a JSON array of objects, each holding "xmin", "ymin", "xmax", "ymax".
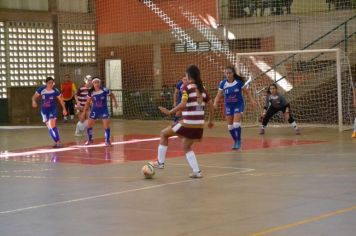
[{"xmin": 7, "ymin": 22, "xmax": 54, "ymax": 87}]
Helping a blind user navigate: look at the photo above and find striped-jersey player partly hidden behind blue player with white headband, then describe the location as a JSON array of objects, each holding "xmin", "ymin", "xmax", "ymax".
[{"xmin": 74, "ymin": 75, "xmax": 92, "ymax": 136}]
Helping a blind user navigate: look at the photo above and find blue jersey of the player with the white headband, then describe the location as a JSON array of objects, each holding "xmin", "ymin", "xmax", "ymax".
[{"xmin": 88, "ymin": 87, "xmax": 111, "ymax": 119}]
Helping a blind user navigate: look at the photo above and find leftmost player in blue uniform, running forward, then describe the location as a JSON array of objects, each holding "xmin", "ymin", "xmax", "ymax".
[{"xmin": 32, "ymin": 77, "xmax": 67, "ymax": 148}]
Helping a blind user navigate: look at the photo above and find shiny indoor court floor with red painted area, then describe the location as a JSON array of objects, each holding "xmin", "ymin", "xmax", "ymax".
[{"xmin": 0, "ymin": 120, "xmax": 356, "ymax": 236}]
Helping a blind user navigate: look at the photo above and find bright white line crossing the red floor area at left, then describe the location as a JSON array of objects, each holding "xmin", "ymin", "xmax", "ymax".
[{"xmin": 0, "ymin": 136, "xmax": 178, "ymax": 158}]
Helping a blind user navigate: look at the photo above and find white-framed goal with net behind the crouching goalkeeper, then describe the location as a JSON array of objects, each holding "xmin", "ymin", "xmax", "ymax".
[{"xmin": 236, "ymin": 48, "xmax": 355, "ymax": 132}]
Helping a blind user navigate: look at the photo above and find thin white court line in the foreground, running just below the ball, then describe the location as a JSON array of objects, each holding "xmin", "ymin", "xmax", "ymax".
[{"xmin": 0, "ymin": 168, "xmax": 254, "ymax": 215}]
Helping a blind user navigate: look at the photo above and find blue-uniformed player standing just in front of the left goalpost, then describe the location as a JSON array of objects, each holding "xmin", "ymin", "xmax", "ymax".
[{"xmin": 214, "ymin": 66, "xmax": 256, "ymax": 149}]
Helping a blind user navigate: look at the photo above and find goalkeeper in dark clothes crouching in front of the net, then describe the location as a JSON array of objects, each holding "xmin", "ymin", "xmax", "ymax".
[{"xmin": 260, "ymin": 84, "xmax": 300, "ymax": 135}]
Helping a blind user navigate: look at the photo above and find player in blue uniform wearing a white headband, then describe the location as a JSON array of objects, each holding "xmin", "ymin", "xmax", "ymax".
[{"xmin": 83, "ymin": 77, "xmax": 118, "ymax": 147}]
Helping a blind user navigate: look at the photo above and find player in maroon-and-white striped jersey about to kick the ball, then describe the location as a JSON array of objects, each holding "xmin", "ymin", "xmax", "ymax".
[{"xmin": 151, "ymin": 65, "xmax": 214, "ymax": 178}]
